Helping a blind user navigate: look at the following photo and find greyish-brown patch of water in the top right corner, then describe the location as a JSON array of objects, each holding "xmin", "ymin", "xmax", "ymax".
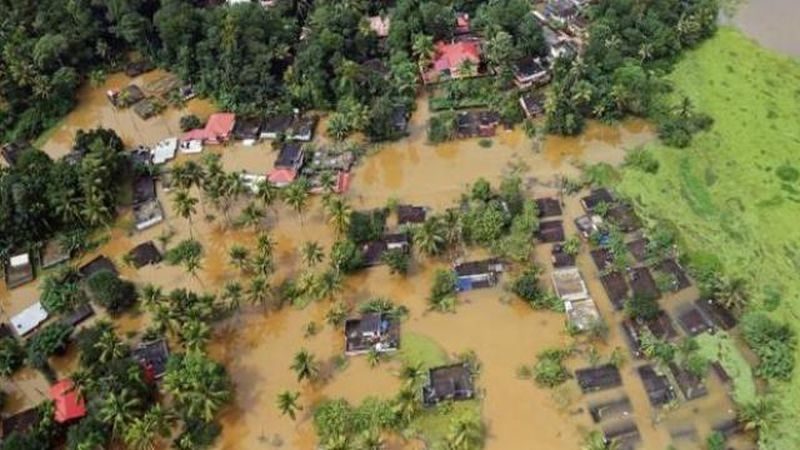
[{"xmin": 733, "ymin": 0, "xmax": 800, "ymax": 57}]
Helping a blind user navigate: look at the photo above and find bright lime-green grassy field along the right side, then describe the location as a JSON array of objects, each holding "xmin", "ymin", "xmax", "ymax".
[{"xmin": 618, "ymin": 28, "xmax": 800, "ymax": 449}]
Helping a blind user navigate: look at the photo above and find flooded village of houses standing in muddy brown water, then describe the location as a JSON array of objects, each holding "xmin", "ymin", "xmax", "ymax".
[{"xmin": 0, "ymin": 1, "xmax": 792, "ymax": 450}]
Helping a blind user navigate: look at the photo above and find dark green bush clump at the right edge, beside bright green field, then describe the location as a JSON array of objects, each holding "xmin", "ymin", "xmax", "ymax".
[{"xmin": 741, "ymin": 312, "xmax": 797, "ymax": 380}]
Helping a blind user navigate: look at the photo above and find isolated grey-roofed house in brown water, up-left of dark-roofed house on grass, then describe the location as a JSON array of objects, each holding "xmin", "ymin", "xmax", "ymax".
[{"xmin": 344, "ymin": 313, "xmax": 400, "ymax": 355}]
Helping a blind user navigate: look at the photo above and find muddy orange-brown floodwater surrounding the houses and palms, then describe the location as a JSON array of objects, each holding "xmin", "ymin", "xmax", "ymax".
[{"xmin": 0, "ymin": 72, "xmax": 752, "ymax": 450}]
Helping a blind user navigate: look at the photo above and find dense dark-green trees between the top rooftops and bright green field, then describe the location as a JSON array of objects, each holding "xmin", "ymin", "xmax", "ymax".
[{"xmin": 547, "ymin": 0, "xmax": 719, "ymax": 146}]
